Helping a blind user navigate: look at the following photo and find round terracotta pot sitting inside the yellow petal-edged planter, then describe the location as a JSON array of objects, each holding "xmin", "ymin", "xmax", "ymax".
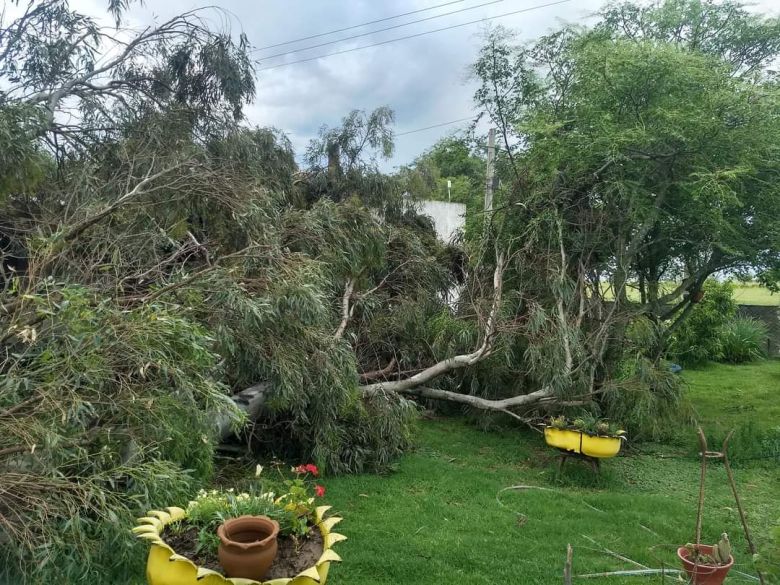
[{"xmin": 217, "ymin": 516, "xmax": 279, "ymax": 581}]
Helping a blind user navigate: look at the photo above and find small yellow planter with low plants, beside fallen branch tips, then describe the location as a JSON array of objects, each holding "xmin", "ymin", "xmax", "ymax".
[{"xmin": 544, "ymin": 415, "xmax": 626, "ymax": 458}]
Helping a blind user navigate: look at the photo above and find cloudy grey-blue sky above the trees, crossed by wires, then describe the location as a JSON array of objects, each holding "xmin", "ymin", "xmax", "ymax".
[{"xmin": 71, "ymin": 0, "xmax": 780, "ymax": 168}]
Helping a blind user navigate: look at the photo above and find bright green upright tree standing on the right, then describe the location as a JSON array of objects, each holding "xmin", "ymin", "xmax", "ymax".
[{"xmin": 438, "ymin": 0, "xmax": 780, "ymax": 428}]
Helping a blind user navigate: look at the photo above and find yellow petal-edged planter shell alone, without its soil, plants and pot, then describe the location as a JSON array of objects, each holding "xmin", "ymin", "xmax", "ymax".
[{"xmin": 133, "ymin": 506, "xmax": 347, "ymax": 585}]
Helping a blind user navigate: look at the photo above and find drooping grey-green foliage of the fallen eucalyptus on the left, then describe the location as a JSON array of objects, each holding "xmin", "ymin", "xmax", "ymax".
[{"xmin": 0, "ymin": 0, "xmax": 451, "ymax": 583}]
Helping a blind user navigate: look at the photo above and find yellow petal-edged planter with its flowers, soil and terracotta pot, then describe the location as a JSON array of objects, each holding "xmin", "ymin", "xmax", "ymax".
[{"xmin": 133, "ymin": 465, "xmax": 345, "ymax": 585}]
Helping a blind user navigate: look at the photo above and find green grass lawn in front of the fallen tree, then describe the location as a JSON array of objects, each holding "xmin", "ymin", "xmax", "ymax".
[{"xmin": 320, "ymin": 362, "xmax": 780, "ymax": 585}]
